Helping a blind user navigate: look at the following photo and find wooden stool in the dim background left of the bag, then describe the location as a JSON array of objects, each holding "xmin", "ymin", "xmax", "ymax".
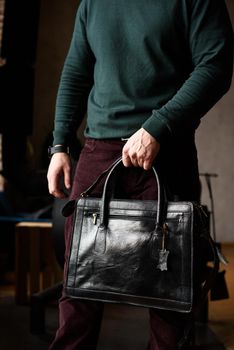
[{"xmin": 15, "ymin": 221, "xmax": 61, "ymax": 304}]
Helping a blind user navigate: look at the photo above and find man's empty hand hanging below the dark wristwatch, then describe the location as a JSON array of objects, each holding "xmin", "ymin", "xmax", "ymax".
[{"xmin": 47, "ymin": 152, "xmax": 71, "ymax": 198}]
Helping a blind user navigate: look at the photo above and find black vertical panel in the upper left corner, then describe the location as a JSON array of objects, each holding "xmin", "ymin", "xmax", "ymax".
[{"xmin": 0, "ymin": 0, "xmax": 40, "ymax": 134}]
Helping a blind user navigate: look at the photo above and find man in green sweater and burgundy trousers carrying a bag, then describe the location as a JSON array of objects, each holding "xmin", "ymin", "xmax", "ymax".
[{"xmin": 48, "ymin": 0, "xmax": 233, "ymax": 350}]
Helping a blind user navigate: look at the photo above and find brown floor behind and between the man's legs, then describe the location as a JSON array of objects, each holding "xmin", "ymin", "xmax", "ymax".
[{"xmin": 0, "ymin": 244, "xmax": 234, "ymax": 350}]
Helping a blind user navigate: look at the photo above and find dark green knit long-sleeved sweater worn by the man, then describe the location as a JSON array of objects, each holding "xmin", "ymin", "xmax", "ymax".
[{"xmin": 54, "ymin": 0, "xmax": 233, "ymax": 144}]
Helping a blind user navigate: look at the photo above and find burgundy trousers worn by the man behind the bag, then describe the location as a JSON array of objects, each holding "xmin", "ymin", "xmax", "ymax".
[{"xmin": 49, "ymin": 139, "xmax": 196, "ymax": 350}]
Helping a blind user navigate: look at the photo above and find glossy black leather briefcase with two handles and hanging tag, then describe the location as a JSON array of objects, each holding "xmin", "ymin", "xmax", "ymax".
[{"xmin": 63, "ymin": 160, "xmax": 218, "ymax": 313}]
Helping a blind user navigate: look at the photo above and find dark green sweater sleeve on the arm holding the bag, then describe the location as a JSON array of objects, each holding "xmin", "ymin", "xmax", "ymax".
[{"xmin": 143, "ymin": 0, "xmax": 233, "ymax": 142}]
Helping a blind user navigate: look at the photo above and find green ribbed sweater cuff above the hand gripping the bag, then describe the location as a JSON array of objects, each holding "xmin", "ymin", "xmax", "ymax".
[{"xmin": 142, "ymin": 113, "xmax": 171, "ymax": 143}]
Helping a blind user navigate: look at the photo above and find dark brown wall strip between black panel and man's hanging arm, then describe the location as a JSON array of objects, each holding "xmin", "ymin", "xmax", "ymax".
[{"xmin": 30, "ymin": 0, "xmax": 79, "ymax": 166}]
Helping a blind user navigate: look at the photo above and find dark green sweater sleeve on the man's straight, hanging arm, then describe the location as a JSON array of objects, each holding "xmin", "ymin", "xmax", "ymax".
[{"xmin": 53, "ymin": 2, "xmax": 95, "ymax": 145}]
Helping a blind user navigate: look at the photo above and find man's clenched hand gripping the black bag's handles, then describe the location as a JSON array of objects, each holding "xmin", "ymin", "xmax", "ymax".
[{"xmin": 122, "ymin": 128, "xmax": 160, "ymax": 170}]
